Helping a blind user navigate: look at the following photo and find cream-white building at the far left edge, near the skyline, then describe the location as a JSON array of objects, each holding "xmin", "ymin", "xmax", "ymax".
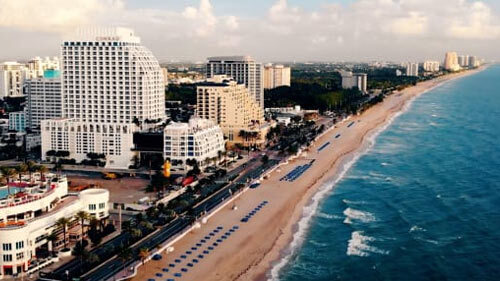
[{"xmin": 0, "ymin": 62, "xmax": 26, "ymax": 99}]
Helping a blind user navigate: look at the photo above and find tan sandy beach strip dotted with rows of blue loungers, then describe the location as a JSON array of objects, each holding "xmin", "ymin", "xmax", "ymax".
[{"xmin": 131, "ymin": 69, "xmax": 482, "ymax": 281}]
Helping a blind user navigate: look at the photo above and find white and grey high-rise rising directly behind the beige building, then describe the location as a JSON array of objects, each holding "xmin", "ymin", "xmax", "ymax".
[{"xmin": 206, "ymin": 56, "xmax": 264, "ymax": 108}]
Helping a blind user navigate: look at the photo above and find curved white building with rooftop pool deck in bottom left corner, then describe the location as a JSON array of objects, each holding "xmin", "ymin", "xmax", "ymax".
[{"xmin": 0, "ymin": 174, "xmax": 109, "ymax": 279}]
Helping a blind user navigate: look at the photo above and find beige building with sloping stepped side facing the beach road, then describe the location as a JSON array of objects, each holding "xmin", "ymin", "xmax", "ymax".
[{"xmin": 197, "ymin": 75, "xmax": 267, "ymax": 145}]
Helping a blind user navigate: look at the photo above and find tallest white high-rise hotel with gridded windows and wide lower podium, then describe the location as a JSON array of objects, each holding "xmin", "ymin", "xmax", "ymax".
[{"xmin": 41, "ymin": 28, "xmax": 165, "ymax": 169}]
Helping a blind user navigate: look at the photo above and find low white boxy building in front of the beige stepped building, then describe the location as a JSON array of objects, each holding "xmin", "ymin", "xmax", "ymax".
[{"xmin": 163, "ymin": 118, "xmax": 225, "ymax": 165}]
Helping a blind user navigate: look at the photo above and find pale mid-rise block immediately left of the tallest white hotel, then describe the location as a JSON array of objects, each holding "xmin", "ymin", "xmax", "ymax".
[{"xmin": 24, "ymin": 74, "xmax": 62, "ymax": 130}]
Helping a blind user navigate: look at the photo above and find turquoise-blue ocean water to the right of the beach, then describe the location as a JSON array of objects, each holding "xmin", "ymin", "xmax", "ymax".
[{"xmin": 278, "ymin": 66, "xmax": 500, "ymax": 281}]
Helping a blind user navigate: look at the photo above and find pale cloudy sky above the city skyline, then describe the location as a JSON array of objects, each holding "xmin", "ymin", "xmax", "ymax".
[{"xmin": 0, "ymin": 0, "xmax": 500, "ymax": 62}]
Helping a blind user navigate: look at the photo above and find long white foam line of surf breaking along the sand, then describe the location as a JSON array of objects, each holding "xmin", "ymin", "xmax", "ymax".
[{"xmin": 267, "ymin": 91, "xmax": 418, "ymax": 281}]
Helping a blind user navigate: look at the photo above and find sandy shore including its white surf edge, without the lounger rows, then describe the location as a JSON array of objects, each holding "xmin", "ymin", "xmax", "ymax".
[{"xmin": 132, "ymin": 67, "xmax": 485, "ymax": 280}]
